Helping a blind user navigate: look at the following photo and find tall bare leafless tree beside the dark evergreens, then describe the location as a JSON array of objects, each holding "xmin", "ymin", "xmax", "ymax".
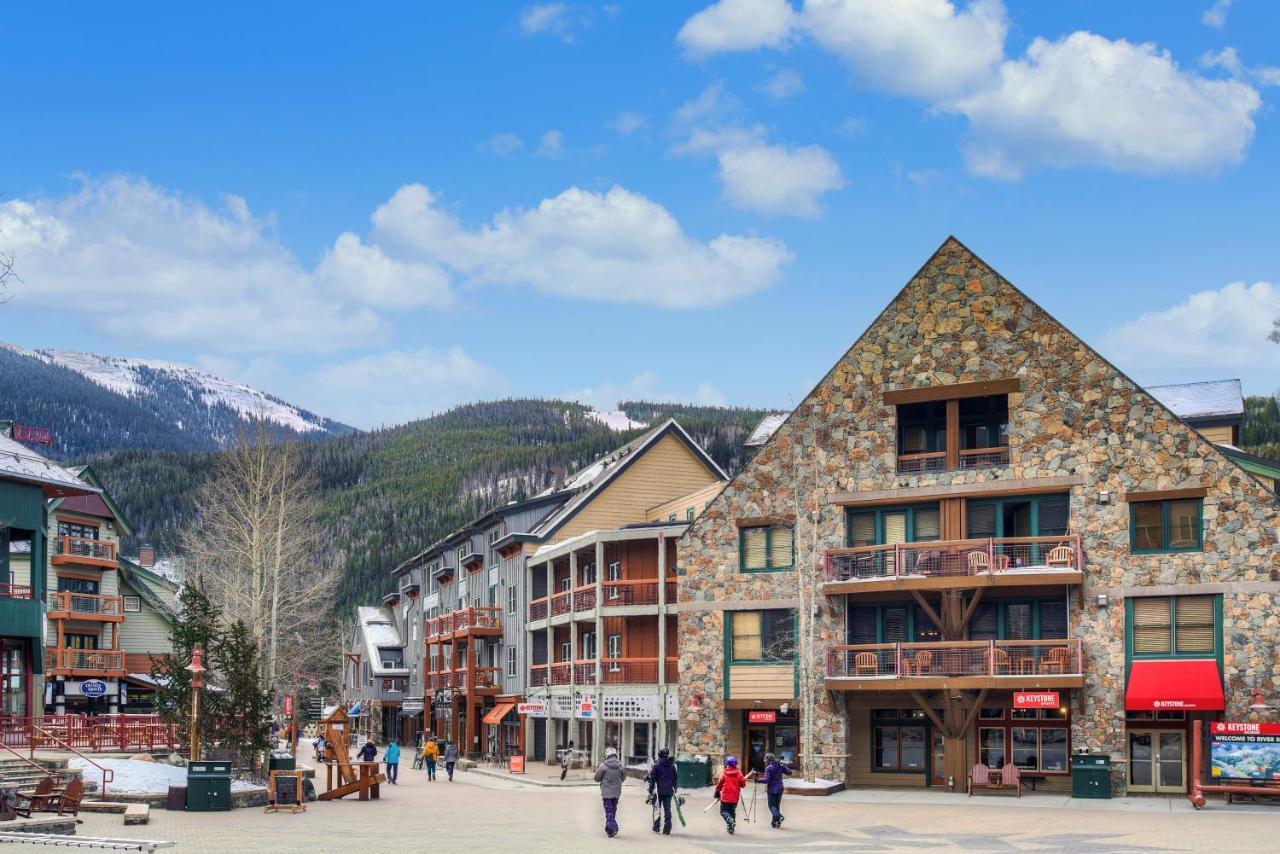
[{"xmin": 183, "ymin": 417, "xmax": 338, "ymax": 691}]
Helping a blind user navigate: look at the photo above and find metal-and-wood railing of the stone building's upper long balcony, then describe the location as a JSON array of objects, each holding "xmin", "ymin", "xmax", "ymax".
[{"xmin": 823, "ymin": 534, "xmax": 1084, "ymax": 581}]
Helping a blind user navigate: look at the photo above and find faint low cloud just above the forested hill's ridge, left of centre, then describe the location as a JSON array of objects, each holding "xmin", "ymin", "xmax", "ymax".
[{"xmin": 305, "ymin": 347, "xmax": 511, "ymax": 428}]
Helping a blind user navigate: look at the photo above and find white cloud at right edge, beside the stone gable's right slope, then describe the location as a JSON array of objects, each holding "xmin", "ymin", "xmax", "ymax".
[{"xmin": 1098, "ymin": 282, "xmax": 1280, "ymax": 393}]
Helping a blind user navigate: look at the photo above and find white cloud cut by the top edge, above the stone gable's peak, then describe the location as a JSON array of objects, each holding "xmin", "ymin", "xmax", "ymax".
[{"xmin": 803, "ymin": 0, "xmax": 1009, "ymax": 99}]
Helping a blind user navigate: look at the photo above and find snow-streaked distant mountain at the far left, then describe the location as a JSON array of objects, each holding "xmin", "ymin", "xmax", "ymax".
[{"xmin": 0, "ymin": 344, "xmax": 352, "ymax": 458}]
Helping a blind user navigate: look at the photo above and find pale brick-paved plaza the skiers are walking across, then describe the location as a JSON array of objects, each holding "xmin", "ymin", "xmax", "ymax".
[{"xmin": 64, "ymin": 768, "xmax": 1280, "ymax": 854}]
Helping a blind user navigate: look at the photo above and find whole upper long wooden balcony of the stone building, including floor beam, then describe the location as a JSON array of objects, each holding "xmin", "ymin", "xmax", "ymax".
[{"xmin": 822, "ymin": 534, "xmax": 1084, "ymax": 595}]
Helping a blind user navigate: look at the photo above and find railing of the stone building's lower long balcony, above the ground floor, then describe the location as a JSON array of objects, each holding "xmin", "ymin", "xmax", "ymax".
[{"xmin": 827, "ymin": 638, "xmax": 1084, "ymax": 679}]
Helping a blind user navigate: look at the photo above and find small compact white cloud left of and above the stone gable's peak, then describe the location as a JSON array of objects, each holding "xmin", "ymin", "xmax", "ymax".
[{"xmin": 719, "ymin": 145, "xmax": 845, "ymax": 218}]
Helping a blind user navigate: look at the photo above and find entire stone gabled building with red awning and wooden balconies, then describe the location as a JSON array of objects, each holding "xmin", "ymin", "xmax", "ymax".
[{"xmin": 678, "ymin": 238, "xmax": 1280, "ymax": 793}]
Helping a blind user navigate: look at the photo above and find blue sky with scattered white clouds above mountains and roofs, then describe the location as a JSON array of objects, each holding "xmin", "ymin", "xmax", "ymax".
[{"xmin": 0, "ymin": 0, "xmax": 1280, "ymax": 426}]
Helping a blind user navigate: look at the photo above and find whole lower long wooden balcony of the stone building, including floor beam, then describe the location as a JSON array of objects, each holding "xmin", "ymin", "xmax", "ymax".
[{"xmin": 827, "ymin": 638, "xmax": 1084, "ymax": 691}]
